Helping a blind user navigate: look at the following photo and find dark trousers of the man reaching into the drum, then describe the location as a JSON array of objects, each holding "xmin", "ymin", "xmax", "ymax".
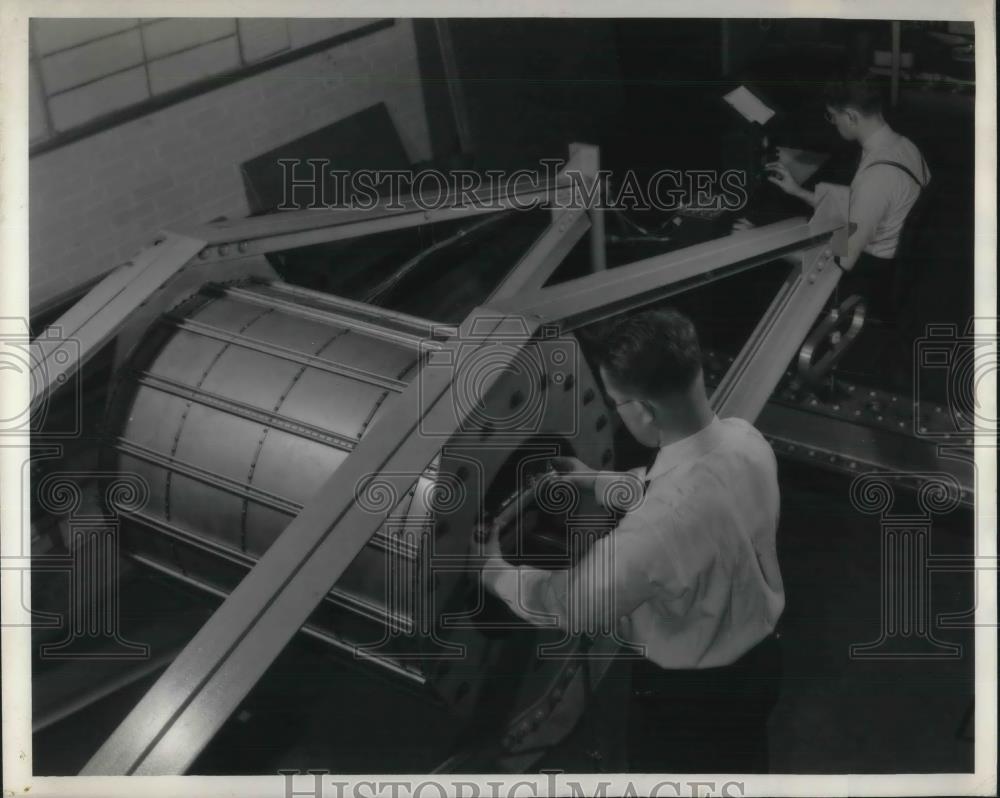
[{"xmin": 629, "ymin": 635, "xmax": 781, "ymax": 773}]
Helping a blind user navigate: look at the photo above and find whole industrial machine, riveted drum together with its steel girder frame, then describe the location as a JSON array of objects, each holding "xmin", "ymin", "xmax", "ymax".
[{"xmin": 23, "ymin": 145, "xmax": 971, "ymax": 775}]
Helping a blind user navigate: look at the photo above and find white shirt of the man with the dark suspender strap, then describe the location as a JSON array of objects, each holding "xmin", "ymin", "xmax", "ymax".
[{"xmin": 816, "ymin": 125, "xmax": 931, "ymax": 258}]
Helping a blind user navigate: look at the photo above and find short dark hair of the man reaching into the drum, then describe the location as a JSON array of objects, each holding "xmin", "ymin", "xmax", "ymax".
[{"xmin": 598, "ymin": 310, "xmax": 701, "ymax": 398}]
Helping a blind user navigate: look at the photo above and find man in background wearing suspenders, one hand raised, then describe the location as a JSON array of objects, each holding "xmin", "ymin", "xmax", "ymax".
[{"xmin": 768, "ymin": 80, "xmax": 931, "ymax": 320}]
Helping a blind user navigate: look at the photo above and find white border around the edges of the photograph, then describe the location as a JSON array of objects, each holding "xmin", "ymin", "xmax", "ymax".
[{"xmin": 0, "ymin": 0, "xmax": 997, "ymax": 798}]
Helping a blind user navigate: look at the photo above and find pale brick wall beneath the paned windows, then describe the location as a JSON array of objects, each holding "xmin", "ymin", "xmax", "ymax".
[{"xmin": 28, "ymin": 20, "xmax": 430, "ymax": 307}]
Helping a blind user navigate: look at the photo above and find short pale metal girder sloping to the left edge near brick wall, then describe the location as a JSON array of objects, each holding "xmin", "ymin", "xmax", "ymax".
[{"xmin": 31, "ymin": 233, "xmax": 205, "ymax": 406}]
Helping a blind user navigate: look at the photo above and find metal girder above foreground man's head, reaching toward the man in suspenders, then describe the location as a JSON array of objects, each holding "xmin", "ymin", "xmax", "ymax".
[{"xmin": 493, "ymin": 218, "xmax": 843, "ymax": 331}]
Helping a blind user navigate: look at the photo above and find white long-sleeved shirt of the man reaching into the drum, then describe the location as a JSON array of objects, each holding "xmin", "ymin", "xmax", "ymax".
[{"xmin": 483, "ymin": 417, "xmax": 785, "ymax": 668}]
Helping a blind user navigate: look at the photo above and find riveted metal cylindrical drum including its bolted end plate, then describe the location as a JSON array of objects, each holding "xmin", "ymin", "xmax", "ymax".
[{"xmin": 103, "ymin": 282, "xmax": 612, "ymax": 720}]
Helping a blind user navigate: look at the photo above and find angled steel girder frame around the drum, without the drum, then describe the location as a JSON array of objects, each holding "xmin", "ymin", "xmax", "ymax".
[{"xmin": 32, "ymin": 145, "xmax": 846, "ymax": 775}]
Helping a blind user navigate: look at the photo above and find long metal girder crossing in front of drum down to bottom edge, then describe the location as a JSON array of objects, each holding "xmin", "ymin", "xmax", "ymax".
[{"xmin": 81, "ymin": 308, "xmax": 536, "ymax": 775}]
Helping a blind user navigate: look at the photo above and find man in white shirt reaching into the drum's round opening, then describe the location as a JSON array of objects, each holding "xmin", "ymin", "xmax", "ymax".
[{"xmin": 482, "ymin": 311, "xmax": 785, "ymax": 772}]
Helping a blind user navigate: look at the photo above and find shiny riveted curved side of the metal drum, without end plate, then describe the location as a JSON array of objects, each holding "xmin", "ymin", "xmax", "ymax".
[{"xmin": 108, "ymin": 285, "xmax": 442, "ymax": 676}]
